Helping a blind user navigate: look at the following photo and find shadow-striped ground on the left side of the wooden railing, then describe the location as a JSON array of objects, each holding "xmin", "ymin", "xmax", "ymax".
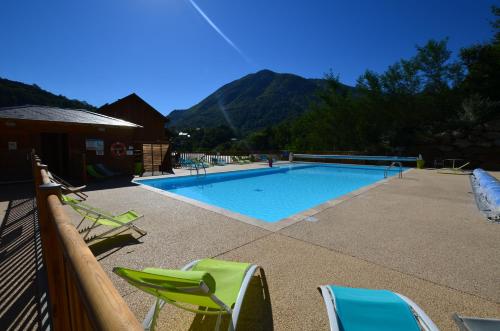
[{"xmin": 0, "ymin": 183, "xmax": 51, "ymax": 330}]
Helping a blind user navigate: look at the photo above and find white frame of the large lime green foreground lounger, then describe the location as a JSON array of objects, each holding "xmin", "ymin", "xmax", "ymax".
[{"xmin": 142, "ymin": 260, "xmax": 264, "ymax": 331}]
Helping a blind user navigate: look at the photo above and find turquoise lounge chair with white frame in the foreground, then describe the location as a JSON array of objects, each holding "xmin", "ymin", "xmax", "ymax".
[{"xmin": 318, "ymin": 285, "xmax": 439, "ymax": 331}]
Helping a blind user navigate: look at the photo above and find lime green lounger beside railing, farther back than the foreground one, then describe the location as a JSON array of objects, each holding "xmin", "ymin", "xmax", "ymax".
[{"xmin": 62, "ymin": 195, "xmax": 147, "ymax": 243}]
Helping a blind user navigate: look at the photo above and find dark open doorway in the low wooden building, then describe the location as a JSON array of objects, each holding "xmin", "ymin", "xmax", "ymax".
[{"xmin": 40, "ymin": 133, "xmax": 69, "ymax": 177}]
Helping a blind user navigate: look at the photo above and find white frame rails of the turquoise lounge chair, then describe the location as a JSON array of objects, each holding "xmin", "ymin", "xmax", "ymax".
[{"xmin": 318, "ymin": 285, "xmax": 439, "ymax": 331}]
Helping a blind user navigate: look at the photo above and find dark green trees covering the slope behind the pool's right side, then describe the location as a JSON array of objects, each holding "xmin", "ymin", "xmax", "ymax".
[{"xmin": 174, "ymin": 6, "xmax": 500, "ymax": 157}]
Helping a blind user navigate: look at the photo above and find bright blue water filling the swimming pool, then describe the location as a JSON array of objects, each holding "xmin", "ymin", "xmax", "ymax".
[{"xmin": 137, "ymin": 164, "xmax": 398, "ymax": 223}]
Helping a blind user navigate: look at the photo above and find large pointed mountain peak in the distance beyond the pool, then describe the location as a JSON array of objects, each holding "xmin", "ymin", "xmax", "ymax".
[{"xmin": 168, "ymin": 70, "xmax": 336, "ymax": 134}]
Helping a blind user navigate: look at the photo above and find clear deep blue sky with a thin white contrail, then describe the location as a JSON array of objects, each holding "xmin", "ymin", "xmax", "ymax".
[{"xmin": 0, "ymin": 0, "xmax": 495, "ymax": 114}]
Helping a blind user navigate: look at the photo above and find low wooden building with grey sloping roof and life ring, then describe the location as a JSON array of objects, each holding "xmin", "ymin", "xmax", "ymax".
[{"xmin": 0, "ymin": 106, "xmax": 143, "ymax": 181}]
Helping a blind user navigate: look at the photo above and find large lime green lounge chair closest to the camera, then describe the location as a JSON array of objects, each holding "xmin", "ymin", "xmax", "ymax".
[{"xmin": 113, "ymin": 259, "xmax": 264, "ymax": 330}]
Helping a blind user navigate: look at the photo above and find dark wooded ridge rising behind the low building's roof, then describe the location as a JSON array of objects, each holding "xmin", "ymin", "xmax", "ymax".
[{"xmin": 0, "ymin": 78, "xmax": 95, "ymax": 110}]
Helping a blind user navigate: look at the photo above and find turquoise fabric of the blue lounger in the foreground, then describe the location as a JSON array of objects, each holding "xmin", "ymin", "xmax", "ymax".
[{"xmin": 330, "ymin": 285, "xmax": 420, "ymax": 331}]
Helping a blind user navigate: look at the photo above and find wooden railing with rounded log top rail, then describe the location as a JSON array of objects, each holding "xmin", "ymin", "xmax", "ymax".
[{"xmin": 32, "ymin": 155, "xmax": 141, "ymax": 331}]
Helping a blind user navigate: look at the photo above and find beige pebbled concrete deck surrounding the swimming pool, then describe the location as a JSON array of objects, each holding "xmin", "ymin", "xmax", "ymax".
[{"xmin": 61, "ymin": 164, "xmax": 500, "ymax": 330}]
